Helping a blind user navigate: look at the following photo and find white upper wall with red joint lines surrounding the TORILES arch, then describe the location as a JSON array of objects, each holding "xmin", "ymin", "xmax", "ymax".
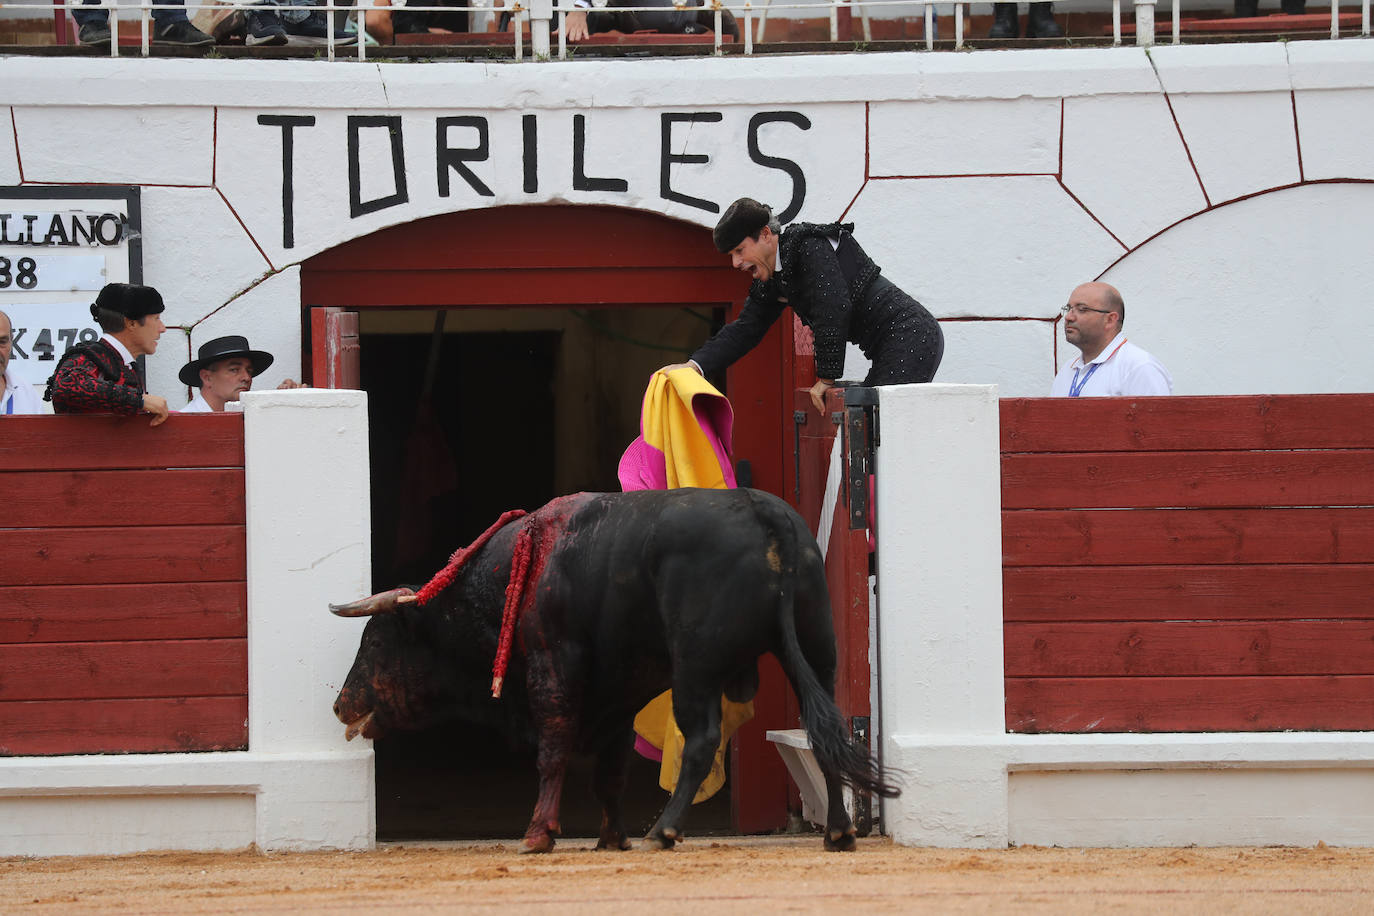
[{"xmin": 0, "ymin": 40, "xmax": 1374, "ymax": 404}]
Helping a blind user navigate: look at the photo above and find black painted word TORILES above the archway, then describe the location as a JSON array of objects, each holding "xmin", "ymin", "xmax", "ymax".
[{"xmin": 257, "ymin": 111, "xmax": 811, "ymax": 249}]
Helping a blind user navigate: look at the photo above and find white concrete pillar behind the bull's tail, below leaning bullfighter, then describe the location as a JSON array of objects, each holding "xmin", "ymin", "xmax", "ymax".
[{"xmin": 877, "ymin": 385, "xmax": 1007, "ymax": 846}]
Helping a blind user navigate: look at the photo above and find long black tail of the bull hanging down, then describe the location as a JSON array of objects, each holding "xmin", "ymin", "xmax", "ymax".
[{"xmin": 779, "ymin": 513, "xmax": 901, "ymax": 798}]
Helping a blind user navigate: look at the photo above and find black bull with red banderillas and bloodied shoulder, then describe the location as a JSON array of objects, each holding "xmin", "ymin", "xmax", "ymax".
[{"xmin": 331, "ymin": 489, "xmax": 897, "ymax": 851}]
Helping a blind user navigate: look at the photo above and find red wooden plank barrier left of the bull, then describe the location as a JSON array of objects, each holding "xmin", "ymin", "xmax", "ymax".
[{"xmin": 0, "ymin": 413, "xmax": 247, "ymax": 755}]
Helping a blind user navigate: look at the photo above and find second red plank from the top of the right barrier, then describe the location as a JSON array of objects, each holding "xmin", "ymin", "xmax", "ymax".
[{"xmin": 1002, "ymin": 449, "xmax": 1374, "ymax": 509}]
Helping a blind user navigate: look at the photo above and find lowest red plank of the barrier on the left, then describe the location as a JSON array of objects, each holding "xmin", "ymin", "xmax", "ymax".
[{"xmin": 0, "ymin": 695, "xmax": 249, "ymax": 757}]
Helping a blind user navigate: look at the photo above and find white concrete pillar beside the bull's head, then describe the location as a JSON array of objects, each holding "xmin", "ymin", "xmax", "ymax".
[{"xmin": 243, "ymin": 389, "xmax": 375, "ymax": 849}]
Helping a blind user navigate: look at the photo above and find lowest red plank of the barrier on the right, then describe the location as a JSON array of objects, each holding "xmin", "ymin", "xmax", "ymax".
[{"xmin": 1006, "ymin": 676, "xmax": 1374, "ymax": 733}]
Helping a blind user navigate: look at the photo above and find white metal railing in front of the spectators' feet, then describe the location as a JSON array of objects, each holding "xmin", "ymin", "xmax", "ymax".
[{"xmin": 42, "ymin": 0, "xmax": 1371, "ymax": 60}]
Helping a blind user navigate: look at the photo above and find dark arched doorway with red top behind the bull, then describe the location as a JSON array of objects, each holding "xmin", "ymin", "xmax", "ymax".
[{"xmin": 301, "ymin": 205, "xmax": 793, "ymax": 836}]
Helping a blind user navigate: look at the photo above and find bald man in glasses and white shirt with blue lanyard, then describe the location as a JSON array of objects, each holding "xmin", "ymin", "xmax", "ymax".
[{"xmin": 1050, "ymin": 283, "xmax": 1173, "ymax": 397}]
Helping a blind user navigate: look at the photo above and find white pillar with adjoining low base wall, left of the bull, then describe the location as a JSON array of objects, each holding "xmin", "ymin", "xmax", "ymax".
[{"xmin": 0, "ymin": 389, "xmax": 376, "ymax": 856}]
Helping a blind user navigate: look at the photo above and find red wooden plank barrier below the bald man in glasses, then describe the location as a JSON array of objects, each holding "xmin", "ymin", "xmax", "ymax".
[{"xmin": 1002, "ymin": 394, "xmax": 1374, "ymax": 732}]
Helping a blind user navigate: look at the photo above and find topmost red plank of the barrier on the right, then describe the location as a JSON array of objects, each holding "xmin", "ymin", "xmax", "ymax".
[{"xmin": 1000, "ymin": 394, "xmax": 1374, "ymax": 453}]
